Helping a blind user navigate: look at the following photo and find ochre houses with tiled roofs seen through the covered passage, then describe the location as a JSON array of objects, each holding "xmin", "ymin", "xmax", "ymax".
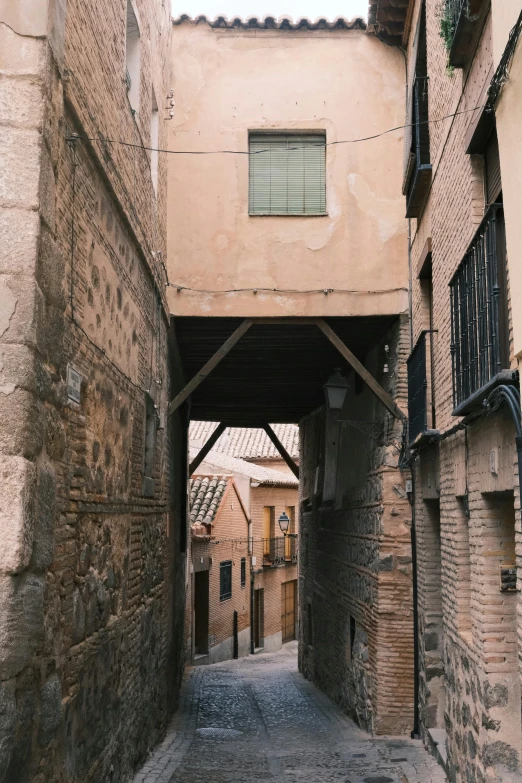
[{"xmin": 185, "ymin": 432, "xmax": 298, "ymax": 663}]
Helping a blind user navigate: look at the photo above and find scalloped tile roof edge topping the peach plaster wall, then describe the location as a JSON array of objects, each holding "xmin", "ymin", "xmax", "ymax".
[{"xmin": 172, "ymin": 14, "xmax": 366, "ymax": 30}]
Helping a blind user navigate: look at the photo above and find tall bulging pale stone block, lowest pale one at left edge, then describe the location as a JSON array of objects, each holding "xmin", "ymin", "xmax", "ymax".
[{"xmin": 0, "ymin": 455, "xmax": 36, "ymax": 574}]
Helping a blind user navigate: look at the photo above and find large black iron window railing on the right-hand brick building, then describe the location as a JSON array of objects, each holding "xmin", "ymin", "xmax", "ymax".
[{"xmin": 450, "ymin": 204, "xmax": 509, "ymax": 414}]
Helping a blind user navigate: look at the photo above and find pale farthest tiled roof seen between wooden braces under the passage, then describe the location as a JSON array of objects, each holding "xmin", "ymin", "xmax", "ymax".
[{"xmin": 189, "ymin": 421, "xmax": 299, "ymax": 460}]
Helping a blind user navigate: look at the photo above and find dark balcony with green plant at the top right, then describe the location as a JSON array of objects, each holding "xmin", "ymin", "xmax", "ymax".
[{"xmin": 443, "ymin": 0, "xmax": 489, "ymax": 68}]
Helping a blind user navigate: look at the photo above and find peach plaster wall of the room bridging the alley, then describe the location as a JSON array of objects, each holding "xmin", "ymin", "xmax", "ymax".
[{"xmin": 168, "ymin": 21, "xmax": 407, "ymax": 316}]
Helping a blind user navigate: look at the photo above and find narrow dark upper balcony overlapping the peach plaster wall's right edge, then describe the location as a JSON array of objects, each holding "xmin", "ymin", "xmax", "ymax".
[{"xmin": 405, "ymin": 76, "xmax": 432, "ymax": 218}]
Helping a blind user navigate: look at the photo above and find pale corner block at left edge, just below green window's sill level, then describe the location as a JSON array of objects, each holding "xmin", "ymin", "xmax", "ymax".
[{"xmin": 0, "ymin": 209, "xmax": 40, "ymax": 275}]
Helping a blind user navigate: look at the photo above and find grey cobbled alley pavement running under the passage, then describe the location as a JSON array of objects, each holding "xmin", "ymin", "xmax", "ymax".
[{"xmin": 134, "ymin": 642, "xmax": 446, "ymax": 783}]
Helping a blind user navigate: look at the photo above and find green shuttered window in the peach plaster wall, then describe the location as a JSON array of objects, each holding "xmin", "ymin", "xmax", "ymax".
[{"xmin": 248, "ymin": 133, "xmax": 326, "ymax": 215}]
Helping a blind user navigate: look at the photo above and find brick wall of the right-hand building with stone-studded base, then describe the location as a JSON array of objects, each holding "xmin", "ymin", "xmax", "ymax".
[{"xmin": 408, "ymin": 0, "xmax": 521, "ymax": 783}]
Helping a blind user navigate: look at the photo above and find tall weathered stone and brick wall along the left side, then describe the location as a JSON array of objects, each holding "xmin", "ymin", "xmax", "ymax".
[{"xmin": 0, "ymin": 0, "xmax": 186, "ymax": 783}]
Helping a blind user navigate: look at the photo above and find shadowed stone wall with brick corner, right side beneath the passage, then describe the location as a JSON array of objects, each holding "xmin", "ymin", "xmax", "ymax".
[{"xmin": 299, "ymin": 318, "xmax": 413, "ymax": 734}]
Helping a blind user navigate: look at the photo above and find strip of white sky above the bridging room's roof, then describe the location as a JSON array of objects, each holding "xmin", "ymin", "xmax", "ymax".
[{"xmin": 172, "ymin": 0, "xmax": 368, "ymax": 20}]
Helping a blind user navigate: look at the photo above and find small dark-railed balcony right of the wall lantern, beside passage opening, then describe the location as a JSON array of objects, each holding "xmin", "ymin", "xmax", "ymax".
[{"xmin": 408, "ymin": 330, "xmax": 435, "ymax": 446}]
